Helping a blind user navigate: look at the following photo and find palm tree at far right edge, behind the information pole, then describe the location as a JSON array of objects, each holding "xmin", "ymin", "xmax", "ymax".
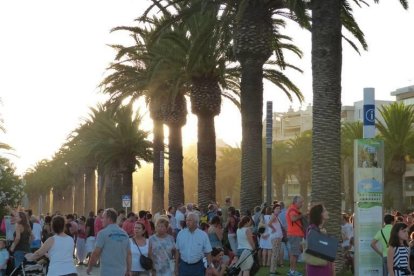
[{"xmin": 376, "ymin": 103, "xmax": 414, "ymax": 210}]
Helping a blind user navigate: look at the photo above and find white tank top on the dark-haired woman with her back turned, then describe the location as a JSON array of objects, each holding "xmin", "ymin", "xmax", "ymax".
[{"xmin": 47, "ymin": 235, "xmax": 77, "ymax": 276}]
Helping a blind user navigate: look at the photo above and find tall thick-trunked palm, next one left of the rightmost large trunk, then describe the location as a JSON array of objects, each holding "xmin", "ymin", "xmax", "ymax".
[{"xmin": 144, "ymin": 0, "xmax": 306, "ymax": 210}]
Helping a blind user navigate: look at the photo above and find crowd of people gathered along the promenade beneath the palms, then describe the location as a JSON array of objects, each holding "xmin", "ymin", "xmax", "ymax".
[{"xmin": 0, "ymin": 196, "xmax": 414, "ymax": 276}]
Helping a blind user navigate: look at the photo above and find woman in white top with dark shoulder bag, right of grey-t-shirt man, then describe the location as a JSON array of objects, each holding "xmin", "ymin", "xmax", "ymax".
[{"xmin": 129, "ymin": 221, "xmax": 149, "ymax": 276}]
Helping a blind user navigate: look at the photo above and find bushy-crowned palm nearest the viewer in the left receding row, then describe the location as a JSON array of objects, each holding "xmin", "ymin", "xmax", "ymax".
[{"xmin": 73, "ymin": 106, "xmax": 152, "ymax": 208}]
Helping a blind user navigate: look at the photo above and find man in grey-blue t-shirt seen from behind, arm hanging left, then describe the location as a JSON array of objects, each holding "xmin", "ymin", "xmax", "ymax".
[{"xmin": 86, "ymin": 208, "xmax": 132, "ymax": 276}]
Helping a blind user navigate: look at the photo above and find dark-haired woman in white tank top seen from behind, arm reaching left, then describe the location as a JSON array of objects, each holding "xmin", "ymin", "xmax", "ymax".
[{"xmin": 25, "ymin": 216, "xmax": 78, "ymax": 276}]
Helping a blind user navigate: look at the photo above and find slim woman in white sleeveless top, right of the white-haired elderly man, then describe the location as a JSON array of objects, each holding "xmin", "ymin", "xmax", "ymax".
[{"xmin": 236, "ymin": 216, "xmax": 255, "ymax": 276}]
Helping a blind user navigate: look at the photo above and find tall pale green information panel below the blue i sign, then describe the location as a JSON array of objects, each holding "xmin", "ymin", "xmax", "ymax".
[{"xmin": 354, "ymin": 139, "xmax": 384, "ymax": 276}]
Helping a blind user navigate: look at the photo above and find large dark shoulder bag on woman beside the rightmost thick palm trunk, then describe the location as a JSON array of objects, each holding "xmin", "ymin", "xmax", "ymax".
[{"xmin": 305, "ymin": 226, "xmax": 339, "ymax": 262}]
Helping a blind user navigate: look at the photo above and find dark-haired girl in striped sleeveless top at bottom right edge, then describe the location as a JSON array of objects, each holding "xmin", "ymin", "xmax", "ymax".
[{"xmin": 387, "ymin": 222, "xmax": 411, "ymax": 276}]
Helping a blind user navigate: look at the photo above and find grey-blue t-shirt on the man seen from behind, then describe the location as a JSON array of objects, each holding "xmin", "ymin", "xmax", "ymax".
[{"xmin": 96, "ymin": 223, "xmax": 131, "ymax": 276}]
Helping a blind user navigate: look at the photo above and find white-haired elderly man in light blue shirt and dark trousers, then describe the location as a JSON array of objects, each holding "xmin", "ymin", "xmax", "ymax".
[{"xmin": 175, "ymin": 213, "xmax": 212, "ymax": 276}]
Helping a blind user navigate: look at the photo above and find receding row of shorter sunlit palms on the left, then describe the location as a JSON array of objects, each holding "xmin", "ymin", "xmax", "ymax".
[{"xmin": 24, "ymin": 103, "xmax": 152, "ymax": 214}]
